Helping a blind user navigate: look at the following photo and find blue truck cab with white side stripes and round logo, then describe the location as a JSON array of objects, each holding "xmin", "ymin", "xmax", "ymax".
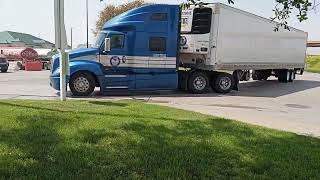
[{"xmin": 51, "ymin": 5, "xmax": 180, "ymax": 96}]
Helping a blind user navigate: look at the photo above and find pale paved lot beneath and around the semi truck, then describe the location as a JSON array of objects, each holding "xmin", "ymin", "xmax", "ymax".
[{"xmin": 0, "ymin": 71, "xmax": 320, "ymax": 137}]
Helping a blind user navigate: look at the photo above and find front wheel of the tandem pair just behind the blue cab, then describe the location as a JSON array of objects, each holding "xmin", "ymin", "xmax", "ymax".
[{"xmin": 188, "ymin": 71, "xmax": 210, "ymax": 94}]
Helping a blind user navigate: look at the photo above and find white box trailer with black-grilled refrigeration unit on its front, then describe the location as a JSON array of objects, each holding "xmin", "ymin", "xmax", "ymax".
[{"xmin": 180, "ymin": 3, "xmax": 308, "ymax": 91}]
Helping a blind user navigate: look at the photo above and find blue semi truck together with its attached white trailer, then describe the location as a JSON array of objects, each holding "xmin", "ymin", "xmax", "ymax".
[{"xmin": 50, "ymin": 3, "xmax": 306, "ymax": 96}]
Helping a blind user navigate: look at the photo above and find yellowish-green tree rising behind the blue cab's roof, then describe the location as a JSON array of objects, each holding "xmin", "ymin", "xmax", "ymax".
[{"xmin": 93, "ymin": 0, "xmax": 148, "ymax": 35}]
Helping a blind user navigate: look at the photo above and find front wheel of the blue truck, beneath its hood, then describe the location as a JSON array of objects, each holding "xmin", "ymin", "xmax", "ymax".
[{"xmin": 69, "ymin": 72, "xmax": 96, "ymax": 96}]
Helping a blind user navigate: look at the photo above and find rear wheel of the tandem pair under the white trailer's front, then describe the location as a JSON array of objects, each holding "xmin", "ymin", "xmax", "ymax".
[{"xmin": 211, "ymin": 73, "xmax": 236, "ymax": 94}]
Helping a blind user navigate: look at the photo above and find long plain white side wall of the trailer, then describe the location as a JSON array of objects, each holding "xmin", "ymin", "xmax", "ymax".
[{"xmin": 215, "ymin": 4, "xmax": 308, "ymax": 70}]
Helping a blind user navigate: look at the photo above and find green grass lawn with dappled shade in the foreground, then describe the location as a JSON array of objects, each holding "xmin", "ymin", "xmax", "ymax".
[{"xmin": 0, "ymin": 101, "xmax": 320, "ymax": 179}]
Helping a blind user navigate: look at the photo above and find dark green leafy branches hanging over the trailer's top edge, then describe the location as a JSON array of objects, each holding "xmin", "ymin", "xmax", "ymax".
[{"xmin": 182, "ymin": 0, "xmax": 320, "ymax": 31}]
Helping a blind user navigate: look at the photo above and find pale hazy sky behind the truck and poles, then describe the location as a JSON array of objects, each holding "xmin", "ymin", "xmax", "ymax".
[{"xmin": 0, "ymin": 0, "xmax": 320, "ymax": 54}]
